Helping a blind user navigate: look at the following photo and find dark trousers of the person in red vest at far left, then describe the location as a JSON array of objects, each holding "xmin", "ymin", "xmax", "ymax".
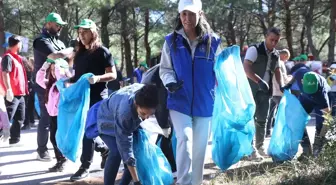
[{"xmin": 5, "ymin": 96, "xmax": 26, "ymax": 142}]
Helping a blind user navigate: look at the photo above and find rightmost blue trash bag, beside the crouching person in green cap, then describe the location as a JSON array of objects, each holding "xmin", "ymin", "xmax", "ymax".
[{"xmin": 268, "ymin": 90, "xmax": 310, "ymax": 162}]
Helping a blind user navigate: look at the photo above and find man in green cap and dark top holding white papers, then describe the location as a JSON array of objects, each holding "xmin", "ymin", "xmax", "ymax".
[{"xmin": 33, "ymin": 13, "xmax": 74, "ymax": 161}]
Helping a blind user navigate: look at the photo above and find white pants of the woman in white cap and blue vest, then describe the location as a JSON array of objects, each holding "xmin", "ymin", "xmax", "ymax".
[{"xmin": 169, "ymin": 110, "xmax": 211, "ymax": 185}]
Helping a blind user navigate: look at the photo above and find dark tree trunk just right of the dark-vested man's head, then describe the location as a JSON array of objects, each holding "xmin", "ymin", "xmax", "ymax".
[{"xmin": 283, "ymin": 0, "xmax": 294, "ymax": 56}]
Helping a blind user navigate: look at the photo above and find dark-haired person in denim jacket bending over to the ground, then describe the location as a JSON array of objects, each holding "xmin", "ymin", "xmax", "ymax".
[{"xmin": 87, "ymin": 83, "xmax": 158, "ymax": 185}]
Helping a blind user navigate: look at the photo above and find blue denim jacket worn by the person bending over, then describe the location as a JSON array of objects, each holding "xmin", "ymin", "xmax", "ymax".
[{"xmin": 97, "ymin": 83, "xmax": 144, "ymax": 166}]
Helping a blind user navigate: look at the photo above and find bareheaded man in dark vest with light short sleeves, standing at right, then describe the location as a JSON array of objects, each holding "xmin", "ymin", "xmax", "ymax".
[{"xmin": 244, "ymin": 28, "xmax": 283, "ymax": 161}]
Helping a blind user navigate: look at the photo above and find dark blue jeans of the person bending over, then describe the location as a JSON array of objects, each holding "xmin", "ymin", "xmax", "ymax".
[{"xmin": 100, "ymin": 135, "xmax": 132, "ymax": 185}]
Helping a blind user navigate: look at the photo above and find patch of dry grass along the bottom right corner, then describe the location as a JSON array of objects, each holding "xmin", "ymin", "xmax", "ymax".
[{"xmin": 211, "ymin": 160, "xmax": 336, "ymax": 185}]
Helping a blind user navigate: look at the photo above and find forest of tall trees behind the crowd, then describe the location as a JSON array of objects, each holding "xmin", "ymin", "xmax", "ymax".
[{"xmin": 0, "ymin": 0, "xmax": 336, "ymax": 76}]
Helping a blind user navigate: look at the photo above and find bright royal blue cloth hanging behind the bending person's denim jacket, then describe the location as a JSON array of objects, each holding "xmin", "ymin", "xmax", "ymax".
[{"xmin": 85, "ymin": 100, "xmax": 103, "ymax": 139}]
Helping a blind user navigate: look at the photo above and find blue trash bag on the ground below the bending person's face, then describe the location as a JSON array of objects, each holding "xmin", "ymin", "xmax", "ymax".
[{"xmin": 133, "ymin": 129, "xmax": 174, "ymax": 185}]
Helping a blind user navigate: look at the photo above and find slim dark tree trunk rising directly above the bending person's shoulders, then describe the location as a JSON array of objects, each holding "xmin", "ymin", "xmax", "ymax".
[{"xmin": 119, "ymin": 5, "xmax": 133, "ymax": 78}]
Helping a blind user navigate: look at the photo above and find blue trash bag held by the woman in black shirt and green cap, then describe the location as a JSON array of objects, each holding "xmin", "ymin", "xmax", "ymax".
[{"xmin": 56, "ymin": 73, "xmax": 93, "ymax": 162}]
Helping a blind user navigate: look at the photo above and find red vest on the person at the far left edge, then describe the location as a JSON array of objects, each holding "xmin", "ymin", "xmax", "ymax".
[{"xmin": 0, "ymin": 51, "xmax": 29, "ymax": 96}]
